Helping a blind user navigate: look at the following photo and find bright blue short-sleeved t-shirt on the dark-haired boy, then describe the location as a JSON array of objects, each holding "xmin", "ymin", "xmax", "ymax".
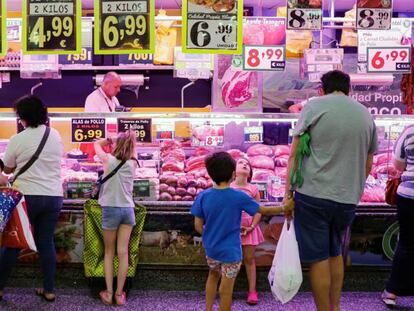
[{"xmin": 191, "ymin": 188, "xmax": 259, "ymax": 263}]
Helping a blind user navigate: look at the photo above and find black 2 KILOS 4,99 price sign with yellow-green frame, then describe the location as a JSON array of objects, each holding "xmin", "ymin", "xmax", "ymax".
[{"xmin": 22, "ymin": 0, "xmax": 82, "ymax": 54}]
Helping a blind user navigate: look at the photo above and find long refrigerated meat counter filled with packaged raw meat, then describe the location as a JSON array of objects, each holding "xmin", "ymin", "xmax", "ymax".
[{"xmin": 0, "ymin": 113, "xmax": 414, "ymax": 266}]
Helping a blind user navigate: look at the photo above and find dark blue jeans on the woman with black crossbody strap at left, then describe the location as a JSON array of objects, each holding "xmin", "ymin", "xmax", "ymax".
[{"xmin": 0, "ymin": 195, "xmax": 63, "ymax": 292}]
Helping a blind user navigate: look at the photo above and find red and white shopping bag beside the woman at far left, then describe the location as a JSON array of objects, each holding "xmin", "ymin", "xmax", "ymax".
[{"xmin": 2, "ymin": 196, "xmax": 37, "ymax": 252}]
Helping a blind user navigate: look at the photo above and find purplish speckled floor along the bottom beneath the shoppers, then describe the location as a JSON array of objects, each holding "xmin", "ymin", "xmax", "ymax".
[{"xmin": 0, "ymin": 288, "xmax": 414, "ymax": 311}]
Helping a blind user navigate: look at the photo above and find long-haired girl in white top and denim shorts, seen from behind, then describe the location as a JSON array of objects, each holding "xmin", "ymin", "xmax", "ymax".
[{"xmin": 94, "ymin": 131, "xmax": 137, "ymax": 305}]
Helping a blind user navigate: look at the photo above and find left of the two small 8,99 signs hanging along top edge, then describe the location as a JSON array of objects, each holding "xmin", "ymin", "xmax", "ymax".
[{"xmin": 287, "ymin": 0, "xmax": 323, "ymax": 30}]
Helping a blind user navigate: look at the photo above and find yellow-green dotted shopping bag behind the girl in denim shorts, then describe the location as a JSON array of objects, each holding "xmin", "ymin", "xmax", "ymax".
[{"xmin": 83, "ymin": 200, "xmax": 147, "ymax": 277}]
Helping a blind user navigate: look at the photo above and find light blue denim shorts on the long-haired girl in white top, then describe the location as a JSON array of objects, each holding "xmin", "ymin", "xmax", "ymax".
[{"xmin": 102, "ymin": 206, "xmax": 135, "ymax": 230}]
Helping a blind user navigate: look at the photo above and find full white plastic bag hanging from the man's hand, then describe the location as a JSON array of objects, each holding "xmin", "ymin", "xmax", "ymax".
[{"xmin": 268, "ymin": 219, "xmax": 303, "ymax": 304}]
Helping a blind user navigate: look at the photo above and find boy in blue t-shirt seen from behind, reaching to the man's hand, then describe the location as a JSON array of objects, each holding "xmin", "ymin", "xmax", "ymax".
[{"xmin": 191, "ymin": 152, "xmax": 294, "ymax": 311}]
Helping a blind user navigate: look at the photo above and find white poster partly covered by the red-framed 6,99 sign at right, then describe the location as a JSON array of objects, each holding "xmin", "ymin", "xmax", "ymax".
[{"xmin": 358, "ymin": 18, "xmax": 412, "ymax": 73}]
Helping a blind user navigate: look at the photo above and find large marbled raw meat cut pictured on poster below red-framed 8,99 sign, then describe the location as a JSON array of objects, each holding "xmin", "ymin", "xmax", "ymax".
[{"xmin": 220, "ymin": 66, "xmax": 253, "ymax": 108}]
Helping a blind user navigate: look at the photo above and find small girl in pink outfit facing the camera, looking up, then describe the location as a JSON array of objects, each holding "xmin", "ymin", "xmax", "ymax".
[{"xmin": 231, "ymin": 159, "xmax": 264, "ymax": 305}]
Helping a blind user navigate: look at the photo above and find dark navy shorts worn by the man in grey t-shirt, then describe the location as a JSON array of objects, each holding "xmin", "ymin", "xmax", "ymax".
[{"xmin": 294, "ymin": 192, "xmax": 356, "ymax": 263}]
